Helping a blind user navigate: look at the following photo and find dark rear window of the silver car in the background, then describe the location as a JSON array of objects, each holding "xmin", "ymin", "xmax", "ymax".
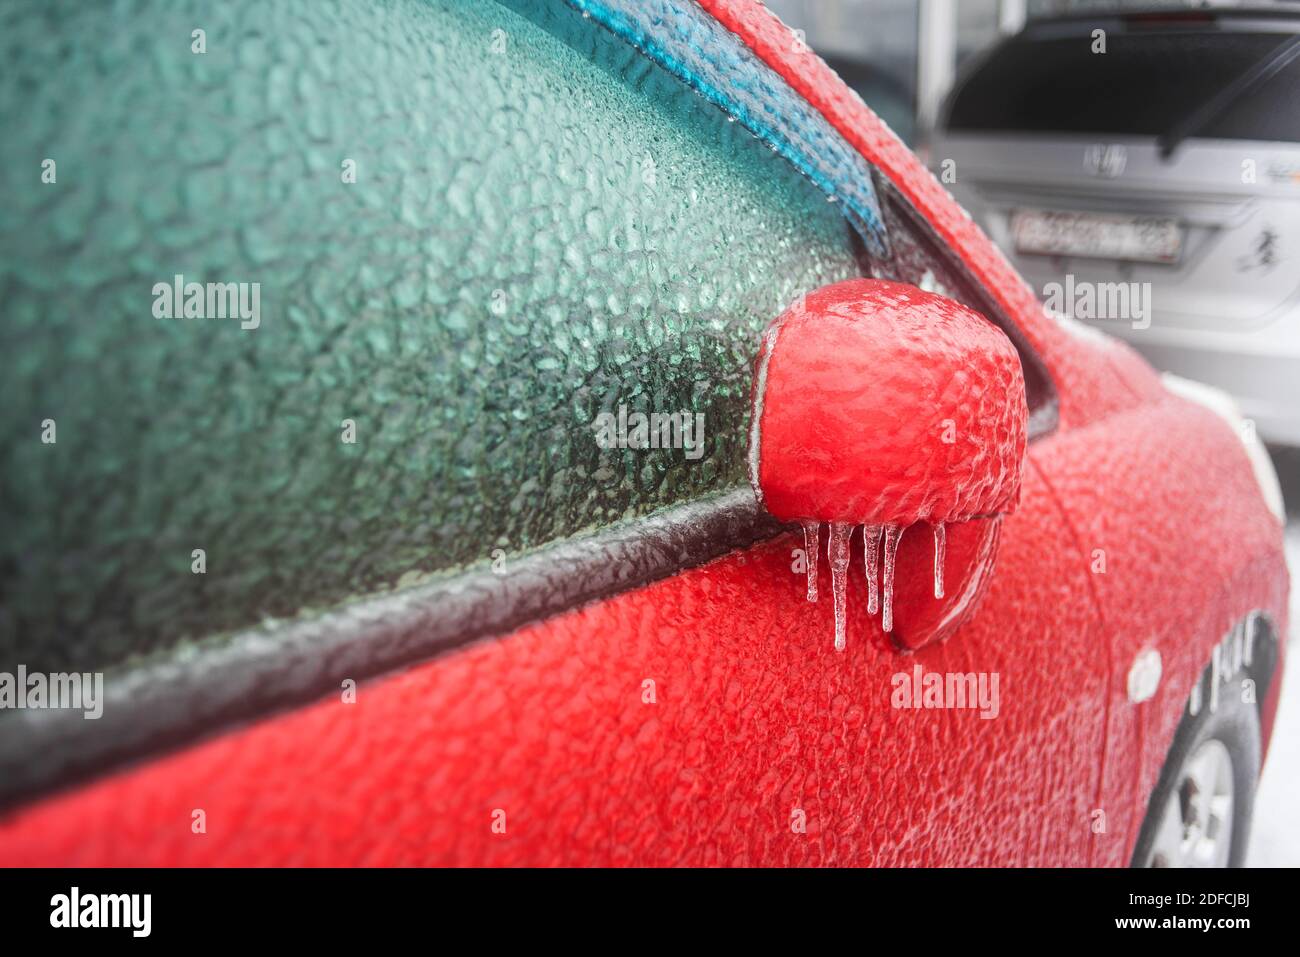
[{"xmin": 948, "ymin": 29, "xmax": 1300, "ymax": 140}]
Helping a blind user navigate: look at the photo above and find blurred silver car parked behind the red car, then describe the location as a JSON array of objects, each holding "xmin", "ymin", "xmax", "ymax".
[{"xmin": 931, "ymin": 4, "xmax": 1300, "ymax": 446}]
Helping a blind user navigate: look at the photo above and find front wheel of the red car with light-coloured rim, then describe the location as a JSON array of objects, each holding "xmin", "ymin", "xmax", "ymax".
[{"xmin": 1134, "ymin": 657, "xmax": 1260, "ymax": 867}]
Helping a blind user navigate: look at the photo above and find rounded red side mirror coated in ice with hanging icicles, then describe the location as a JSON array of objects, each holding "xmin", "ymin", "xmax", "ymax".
[{"xmin": 749, "ymin": 280, "xmax": 1028, "ymax": 649}]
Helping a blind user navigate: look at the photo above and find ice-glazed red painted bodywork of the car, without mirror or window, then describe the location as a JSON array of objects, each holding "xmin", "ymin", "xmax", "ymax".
[{"xmin": 0, "ymin": 0, "xmax": 1288, "ymax": 865}]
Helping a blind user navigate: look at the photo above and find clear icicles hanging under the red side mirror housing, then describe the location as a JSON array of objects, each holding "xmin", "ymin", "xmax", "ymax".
[{"xmin": 802, "ymin": 521, "xmax": 946, "ymax": 651}]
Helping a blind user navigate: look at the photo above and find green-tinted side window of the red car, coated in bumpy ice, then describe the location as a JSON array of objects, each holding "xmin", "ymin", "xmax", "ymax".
[{"xmin": 0, "ymin": 0, "xmax": 858, "ymax": 670}]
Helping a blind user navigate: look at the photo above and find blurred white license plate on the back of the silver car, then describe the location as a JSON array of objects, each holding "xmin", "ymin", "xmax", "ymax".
[{"xmin": 1011, "ymin": 209, "xmax": 1183, "ymax": 263}]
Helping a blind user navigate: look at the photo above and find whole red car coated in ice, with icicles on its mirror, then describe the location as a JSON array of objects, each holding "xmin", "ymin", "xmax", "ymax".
[{"xmin": 0, "ymin": 0, "xmax": 1288, "ymax": 866}]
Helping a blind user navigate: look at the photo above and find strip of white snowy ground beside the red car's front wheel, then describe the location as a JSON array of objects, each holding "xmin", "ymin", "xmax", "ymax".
[{"xmin": 1247, "ymin": 488, "xmax": 1300, "ymax": 867}]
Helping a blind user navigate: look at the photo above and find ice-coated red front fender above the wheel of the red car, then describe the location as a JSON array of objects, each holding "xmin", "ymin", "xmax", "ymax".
[{"xmin": 1030, "ymin": 397, "xmax": 1287, "ymax": 865}]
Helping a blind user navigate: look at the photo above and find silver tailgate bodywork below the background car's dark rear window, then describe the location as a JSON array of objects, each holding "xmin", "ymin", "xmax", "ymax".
[{"xmin": 933, "ymin": 131, "xmax": 1300, "ymax": 332}]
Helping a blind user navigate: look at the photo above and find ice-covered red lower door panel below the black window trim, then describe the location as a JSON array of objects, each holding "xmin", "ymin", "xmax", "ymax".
[{"xmin": 0, "ymin": 455, "xmax": 1105, "ymax": 865}]
